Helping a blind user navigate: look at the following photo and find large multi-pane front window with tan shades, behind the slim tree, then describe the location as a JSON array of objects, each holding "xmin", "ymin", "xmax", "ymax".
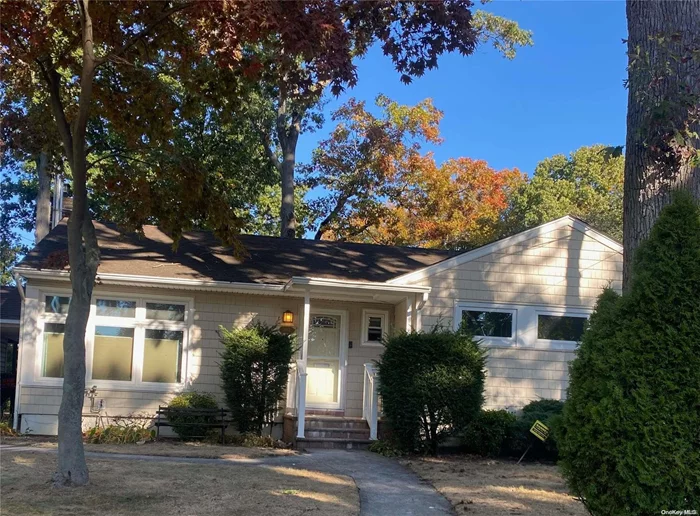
[{"xmin": 39, "ymin": 295, "xmax": 190, "ymax": 390}]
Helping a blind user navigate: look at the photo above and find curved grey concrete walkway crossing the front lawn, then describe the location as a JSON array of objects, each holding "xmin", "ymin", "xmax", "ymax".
[{"xmin": 0, "ymin": 445, "xmax": 454, "ymax": 516}]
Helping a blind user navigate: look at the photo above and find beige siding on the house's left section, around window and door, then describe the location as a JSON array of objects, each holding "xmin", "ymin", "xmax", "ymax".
[{"xmin": 20, "ymin": 281, "xmax": 394, "ymax": 433}]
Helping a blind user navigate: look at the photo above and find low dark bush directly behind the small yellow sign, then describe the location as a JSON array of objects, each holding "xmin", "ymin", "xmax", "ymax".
[{"xmin": 506, "ymin": 400, "xmax": 564, "ymax": 460}]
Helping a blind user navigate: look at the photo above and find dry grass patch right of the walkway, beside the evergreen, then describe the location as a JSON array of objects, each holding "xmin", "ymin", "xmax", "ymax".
[{"xmin": 403, "ymin": 456, "xmax": 587, "ymax": 516}]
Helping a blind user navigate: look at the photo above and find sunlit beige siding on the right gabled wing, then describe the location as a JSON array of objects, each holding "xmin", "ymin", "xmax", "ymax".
[{"xmin": 416, "ymin": 227, "xmax": 622, "ymax": 408}]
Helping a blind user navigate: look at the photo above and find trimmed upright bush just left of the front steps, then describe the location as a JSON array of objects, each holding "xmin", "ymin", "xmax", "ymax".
[{"xmin": 219, "ymin": 323, "xmax": 296, "ymax": 435}]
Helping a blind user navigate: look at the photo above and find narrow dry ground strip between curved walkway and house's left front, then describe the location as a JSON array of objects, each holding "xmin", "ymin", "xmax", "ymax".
[{"xmin": 1, "ymin": 436, "xmax": 297, "ymax": 459}]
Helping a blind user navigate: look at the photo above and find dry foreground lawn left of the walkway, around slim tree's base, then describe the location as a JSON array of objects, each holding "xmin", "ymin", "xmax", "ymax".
[{"xmin": 0, "ymin": 450, "xmax": 359, "ymax": 516}]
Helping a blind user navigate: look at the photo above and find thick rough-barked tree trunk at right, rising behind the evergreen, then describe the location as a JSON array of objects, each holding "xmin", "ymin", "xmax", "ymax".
[{"xmin": 623, "ymin": 0, "xmax": 700, "ymax": 289}]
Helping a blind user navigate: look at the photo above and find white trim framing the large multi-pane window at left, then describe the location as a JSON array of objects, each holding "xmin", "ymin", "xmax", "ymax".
[{"xmin": 32, "ymin": 290, "xmax": 194, "ymax": 392}]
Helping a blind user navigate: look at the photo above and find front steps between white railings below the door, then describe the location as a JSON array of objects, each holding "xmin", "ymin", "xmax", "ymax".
[{"xmin": 285, "ymin": 414, "xmax": 372, "ymax": 450}]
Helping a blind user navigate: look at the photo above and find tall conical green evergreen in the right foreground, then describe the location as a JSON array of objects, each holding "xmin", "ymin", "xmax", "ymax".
[{"xmin": 559, "ymin": 194, "xmax": 700, "ymax": 515}]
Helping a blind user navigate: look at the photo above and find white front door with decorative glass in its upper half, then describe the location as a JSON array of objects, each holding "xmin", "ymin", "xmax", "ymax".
[{"xmin": 306, "ymin": 313, "xmax": 345, "ymax": 408}]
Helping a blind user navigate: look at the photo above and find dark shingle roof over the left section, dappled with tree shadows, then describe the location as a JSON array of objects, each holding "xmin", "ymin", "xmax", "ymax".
[{"xmin": 20, "ymin": 221, "xmax": 455, "ymax": 284}]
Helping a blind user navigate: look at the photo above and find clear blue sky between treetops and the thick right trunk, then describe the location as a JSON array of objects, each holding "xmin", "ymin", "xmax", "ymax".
[{"xmin": 298, "ymin": 0, "xmax": 627, "ymax": 174}]
